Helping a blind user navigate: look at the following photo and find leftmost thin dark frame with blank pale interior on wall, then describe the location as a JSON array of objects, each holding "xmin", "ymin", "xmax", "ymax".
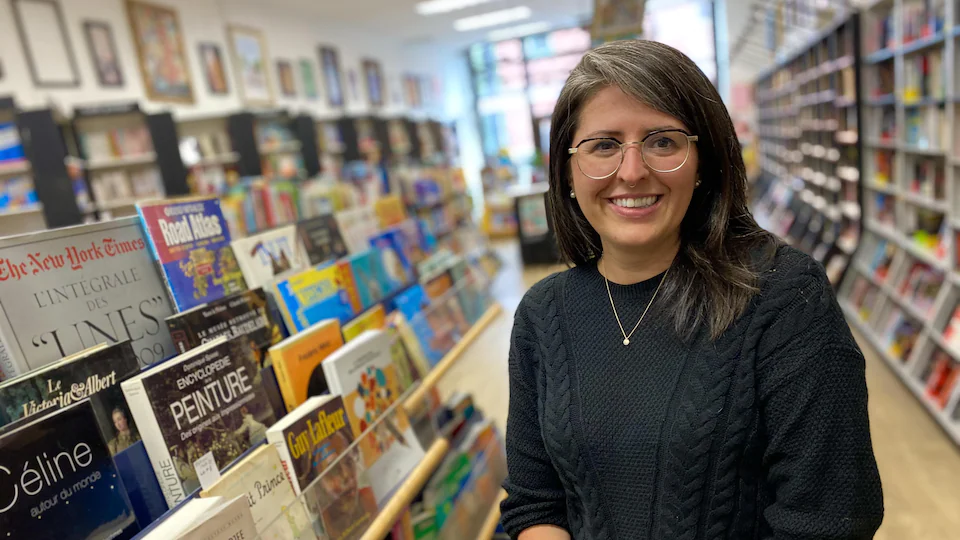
[{"xmin": 12, "ymin": 0, "xmax": 80, "ymax": 88}]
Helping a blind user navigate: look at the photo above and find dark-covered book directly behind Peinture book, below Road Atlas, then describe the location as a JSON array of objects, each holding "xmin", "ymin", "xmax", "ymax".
[{"xmin": 166, "ymin": 289, "xmax": 281, "ymax": 353}]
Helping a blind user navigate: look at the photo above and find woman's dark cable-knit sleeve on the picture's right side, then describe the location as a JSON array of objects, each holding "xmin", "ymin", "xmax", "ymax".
[{"xmin": 757, "ymin": 257, "xmax": 883, "ymax": 540}]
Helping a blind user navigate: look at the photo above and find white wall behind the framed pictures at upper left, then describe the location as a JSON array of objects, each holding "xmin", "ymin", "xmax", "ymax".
[{"xmin": 0, "ymin": 0, "xmax": 446, "ymax": 118}]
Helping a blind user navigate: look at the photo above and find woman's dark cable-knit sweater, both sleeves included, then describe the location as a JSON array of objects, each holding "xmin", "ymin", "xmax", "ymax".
[{"xmin": 501, "ymin": 247, "xmax": 883, "ymax": 540}]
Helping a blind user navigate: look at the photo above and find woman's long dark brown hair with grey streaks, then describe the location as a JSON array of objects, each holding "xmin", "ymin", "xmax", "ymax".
[{"xmin": 547, "ymin": 40, "xmax": 777, "ymax": 339}]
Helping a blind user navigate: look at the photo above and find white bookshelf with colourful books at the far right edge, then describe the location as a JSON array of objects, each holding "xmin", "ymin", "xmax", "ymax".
[{"xmin": 839, "ymin": 0, "xmax": 960, "ymax": 444}]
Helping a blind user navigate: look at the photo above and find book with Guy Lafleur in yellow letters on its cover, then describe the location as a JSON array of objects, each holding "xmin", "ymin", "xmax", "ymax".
[{"xmin": 267, "ymin": 395, "xmax": 353, "ymax": 495}]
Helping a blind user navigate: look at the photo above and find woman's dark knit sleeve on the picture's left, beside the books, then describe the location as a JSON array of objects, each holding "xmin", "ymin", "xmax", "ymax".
[{"xmin": 500, "ymin": 278, "xmax": 568, "ymax": 538}]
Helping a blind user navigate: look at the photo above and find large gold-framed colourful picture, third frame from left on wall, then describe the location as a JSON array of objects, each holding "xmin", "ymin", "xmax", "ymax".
[{"xmin": 127, "ymin": 0, "xmax": 194, "ymax": 103}]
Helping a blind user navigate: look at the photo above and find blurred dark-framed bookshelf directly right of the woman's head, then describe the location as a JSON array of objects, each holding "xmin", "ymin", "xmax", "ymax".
[{"xmin": 753, "ymin": 14, "xmax": 863, "ymax": 286}]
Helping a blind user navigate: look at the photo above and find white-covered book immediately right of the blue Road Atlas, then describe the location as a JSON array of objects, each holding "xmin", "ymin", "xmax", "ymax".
[{"xmin": 230, "ymin": 225, "xmax": 307, "ymax": 289}]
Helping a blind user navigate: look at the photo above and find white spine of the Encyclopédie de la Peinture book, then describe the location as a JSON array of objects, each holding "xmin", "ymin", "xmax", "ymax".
[{"xmin": 120, "ymin": 379, "xmax": 186, "ymax": 508}]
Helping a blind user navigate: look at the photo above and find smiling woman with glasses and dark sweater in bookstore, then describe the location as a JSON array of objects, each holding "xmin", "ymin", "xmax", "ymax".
[{"xmin": 501, "ymin": 41, "xmax": 883, "ymax": 540}]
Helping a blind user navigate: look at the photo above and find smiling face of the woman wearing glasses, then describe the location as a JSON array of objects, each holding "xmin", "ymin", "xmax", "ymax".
[{"xmin": 568, "ymin": 86, "xmax": 698, "ymax": 256}]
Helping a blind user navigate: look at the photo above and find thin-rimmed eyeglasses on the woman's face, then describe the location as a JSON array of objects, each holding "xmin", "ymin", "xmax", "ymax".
[{"xmin": 567, "ymin": 129, "xmax": 699, "ymax": 180}]
